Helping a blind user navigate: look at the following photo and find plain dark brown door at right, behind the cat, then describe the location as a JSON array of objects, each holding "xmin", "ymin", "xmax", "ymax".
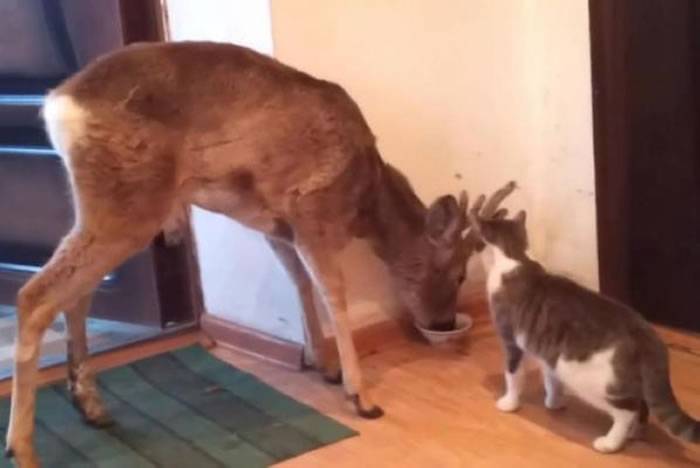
[{"xmin": 590, "ymin": 0, "xmax": 700, "ymax": 331}]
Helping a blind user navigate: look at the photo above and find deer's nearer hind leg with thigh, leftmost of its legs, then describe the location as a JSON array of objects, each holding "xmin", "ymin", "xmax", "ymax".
[{"xmin": 6, "ymin": 230, "xmax": 150, "ymax": 468}]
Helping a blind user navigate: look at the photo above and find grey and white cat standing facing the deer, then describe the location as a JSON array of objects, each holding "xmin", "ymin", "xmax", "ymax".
[{"xmin": 470, "ymin": 211, "xmax": 700, "ymax": 453}]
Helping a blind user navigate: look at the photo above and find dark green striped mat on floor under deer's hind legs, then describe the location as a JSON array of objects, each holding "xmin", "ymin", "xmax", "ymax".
[{"xmin": 0, "ymin": 346, "xmax": 356, "ymax": 468}]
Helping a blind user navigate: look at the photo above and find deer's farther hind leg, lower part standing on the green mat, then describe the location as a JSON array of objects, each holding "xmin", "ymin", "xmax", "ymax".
[{"xmin": 64, "ymin": 294, "xmax": 113, "ymax": 427}]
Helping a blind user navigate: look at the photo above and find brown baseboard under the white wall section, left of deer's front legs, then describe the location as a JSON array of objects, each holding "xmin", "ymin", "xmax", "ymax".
[{"xmin": 201, "ymin": 314, "xmax": 304, "ymax": 369}]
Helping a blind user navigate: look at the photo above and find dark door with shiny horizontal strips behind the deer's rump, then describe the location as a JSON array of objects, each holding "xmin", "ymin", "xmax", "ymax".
[{"xmin": 0, "ymin": 0, "xmax": 196, "ymax": 328}]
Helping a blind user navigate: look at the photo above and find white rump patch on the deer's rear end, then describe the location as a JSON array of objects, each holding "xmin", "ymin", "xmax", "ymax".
[{"xmin": 42, "ymin": 94, "xmax": 88, "ymax": 158}]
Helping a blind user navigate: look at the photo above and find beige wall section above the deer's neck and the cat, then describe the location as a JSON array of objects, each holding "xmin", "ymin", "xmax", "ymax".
[{"xmin": 271, "ymin": 0, "xmax": 598, "ymax": 310}]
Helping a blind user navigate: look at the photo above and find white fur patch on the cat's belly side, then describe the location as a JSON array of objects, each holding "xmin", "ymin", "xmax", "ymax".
[{"xmin": 554, "ymin": 348, "xmax": 615, "ymax": 411}]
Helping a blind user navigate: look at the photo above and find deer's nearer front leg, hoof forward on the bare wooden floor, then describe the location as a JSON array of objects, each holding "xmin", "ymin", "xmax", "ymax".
[{"xmin": 299, "ymin": 243, "xmax": 384, "ymax": 419}]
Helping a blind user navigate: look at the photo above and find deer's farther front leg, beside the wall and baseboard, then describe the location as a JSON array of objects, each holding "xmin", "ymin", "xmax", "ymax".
[{"xmin": 267, "ymin": 236, "xmax": 340, "ymax": 383}]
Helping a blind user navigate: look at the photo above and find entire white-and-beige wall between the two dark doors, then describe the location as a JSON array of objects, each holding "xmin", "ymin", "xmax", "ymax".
[{"xmin": 168, "ymin": 0, "xmax": 598, "ymax": 342}]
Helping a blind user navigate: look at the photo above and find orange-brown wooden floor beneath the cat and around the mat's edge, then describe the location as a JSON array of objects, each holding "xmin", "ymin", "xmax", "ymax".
[{"xmin": 214, "ymin": 319, "xmax": 700, "ymax": 468}]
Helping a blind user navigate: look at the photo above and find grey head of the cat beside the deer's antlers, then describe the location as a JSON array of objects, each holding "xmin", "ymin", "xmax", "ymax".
[{"xmin": 469, "ymin": 210, "xmax": 528, "ymax": 260}]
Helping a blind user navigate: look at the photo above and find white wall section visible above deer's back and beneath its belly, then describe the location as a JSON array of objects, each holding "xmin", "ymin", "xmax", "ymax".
[{"xmin": 167, "ymin": 0, "xmax": 304, "ymax": 343}]
